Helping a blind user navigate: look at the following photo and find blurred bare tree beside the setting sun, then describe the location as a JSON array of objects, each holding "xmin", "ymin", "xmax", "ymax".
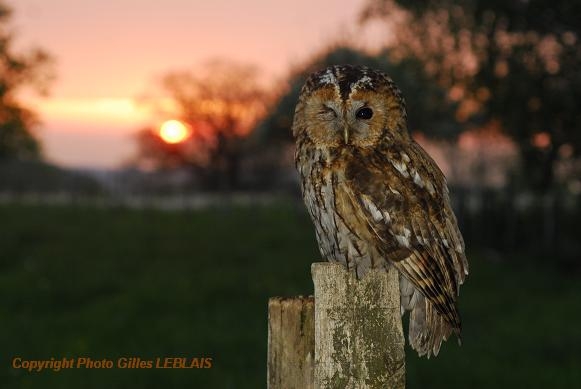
[{"xmin": 138, "ymin": 61, "xmax": 269, "ymax": 189}]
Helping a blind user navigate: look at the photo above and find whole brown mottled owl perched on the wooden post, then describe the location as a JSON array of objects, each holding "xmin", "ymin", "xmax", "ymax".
[{"xmin": 292, "ymin": 65, "xmax": 468, "ymax": 358}]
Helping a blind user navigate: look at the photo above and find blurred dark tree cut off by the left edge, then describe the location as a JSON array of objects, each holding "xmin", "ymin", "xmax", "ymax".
[{"xmin": 0, "ymin": 0, "xmax": 52, "ymax": 161}]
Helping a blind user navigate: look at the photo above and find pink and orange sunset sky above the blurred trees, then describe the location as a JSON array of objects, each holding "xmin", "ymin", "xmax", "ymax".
[{"xmin": 8, "ymin": 0, "xmax": 383, "ymax": 168}]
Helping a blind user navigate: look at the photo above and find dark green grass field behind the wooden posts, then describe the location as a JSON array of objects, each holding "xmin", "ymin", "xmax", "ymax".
[{"xmin": 0, "ymin": 205, "xmax": 581, "ymax": 388}]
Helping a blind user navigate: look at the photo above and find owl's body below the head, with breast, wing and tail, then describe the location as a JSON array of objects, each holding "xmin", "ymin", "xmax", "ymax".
[{"xmin": 300, "ymin": 141, "xmax": 468, "ymax": 355}]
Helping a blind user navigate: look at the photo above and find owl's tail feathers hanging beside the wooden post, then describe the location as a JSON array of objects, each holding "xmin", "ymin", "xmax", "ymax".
[{"xmin": 399, "ymin": 274, "xmax": 460, "ymax": 358}]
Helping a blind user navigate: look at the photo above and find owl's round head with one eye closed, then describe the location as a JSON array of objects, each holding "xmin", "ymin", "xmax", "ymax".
[{"xmin": 293, "ymin": 65, "xmax": 409, "ymax": 148}]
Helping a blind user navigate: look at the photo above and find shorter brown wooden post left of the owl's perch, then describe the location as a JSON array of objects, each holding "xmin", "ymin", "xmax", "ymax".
[{"xmin": 267, "ymin": 296, "xmax": 315, "ymax": 389}]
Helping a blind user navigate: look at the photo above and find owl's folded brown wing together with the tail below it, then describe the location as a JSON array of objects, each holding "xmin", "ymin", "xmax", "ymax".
[{"xmin": 344, "ymin": 142, "xmax": 468, "ymax": 357}]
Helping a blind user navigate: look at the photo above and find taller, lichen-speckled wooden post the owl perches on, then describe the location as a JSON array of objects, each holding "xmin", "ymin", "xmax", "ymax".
[{"xmin": 311, "ymin": 262, "xmax": 405, "ymax": 389}]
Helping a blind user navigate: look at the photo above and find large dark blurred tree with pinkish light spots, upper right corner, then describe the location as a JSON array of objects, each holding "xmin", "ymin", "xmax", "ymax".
[{"xmin": 362, "ymin": 0, "xmax": 581, "ymax": 191}]
